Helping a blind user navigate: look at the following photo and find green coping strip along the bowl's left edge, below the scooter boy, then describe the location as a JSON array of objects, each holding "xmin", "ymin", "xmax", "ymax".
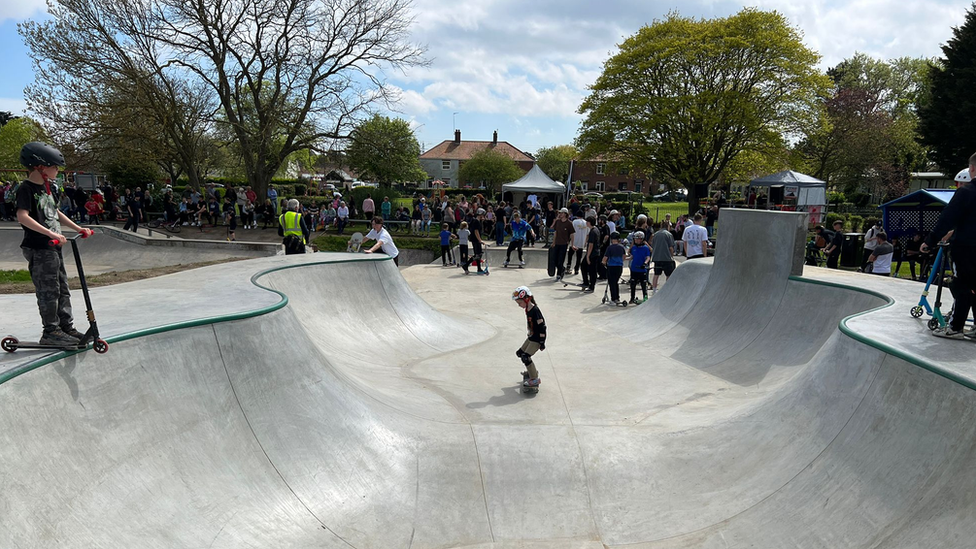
[{"xmin": 0, "ymin": 254, "xmax": 393, "ymax": 385}]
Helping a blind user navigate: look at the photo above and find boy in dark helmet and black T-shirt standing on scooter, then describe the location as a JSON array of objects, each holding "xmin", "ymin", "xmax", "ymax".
[{"xmin": 16, "ymin": 141, "xmax": 93, "ymax": 346}]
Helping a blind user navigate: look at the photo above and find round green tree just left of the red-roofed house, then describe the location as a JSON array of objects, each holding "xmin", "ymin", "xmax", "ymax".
[{"xmin": 346, "ymin": 114, "xmax": 427, "ymax": 185}]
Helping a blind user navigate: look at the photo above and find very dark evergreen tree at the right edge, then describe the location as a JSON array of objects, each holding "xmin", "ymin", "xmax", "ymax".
[{"xmin": 919, "ymin": 4, "xmax": 976, "ymax": 170}]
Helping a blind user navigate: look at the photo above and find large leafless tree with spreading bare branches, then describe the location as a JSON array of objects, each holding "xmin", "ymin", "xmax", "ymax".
[{"xmin": 21, "ymin": 0, "xmax": 425, "ymax": 197}]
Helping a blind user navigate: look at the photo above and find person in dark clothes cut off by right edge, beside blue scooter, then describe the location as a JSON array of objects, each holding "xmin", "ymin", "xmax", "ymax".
[{"xmin": 921, "ymin": 161, "xmax": 976, "ymax": 339}]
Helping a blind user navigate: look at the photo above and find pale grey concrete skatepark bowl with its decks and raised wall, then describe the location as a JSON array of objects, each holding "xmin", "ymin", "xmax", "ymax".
[{"xmin": 0, "ymin": 211, "xmax": 976, "ymax": 549}]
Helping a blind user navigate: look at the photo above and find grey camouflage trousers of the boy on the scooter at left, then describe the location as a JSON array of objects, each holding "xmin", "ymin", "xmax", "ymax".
[{"xmin": 21, "ymin": 247, "xmax": 73, "ymax": 333}]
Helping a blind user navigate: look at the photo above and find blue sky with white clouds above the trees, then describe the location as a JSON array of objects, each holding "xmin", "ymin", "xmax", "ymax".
[{"xmin": 0, "ymin": 0, "xmax": 972, "ymax": 156}]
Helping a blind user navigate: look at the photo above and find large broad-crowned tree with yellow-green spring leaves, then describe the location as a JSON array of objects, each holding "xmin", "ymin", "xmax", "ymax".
[{"xmin": 577, "ymin": 9, "xmax": 829, "ymax": 214}]
